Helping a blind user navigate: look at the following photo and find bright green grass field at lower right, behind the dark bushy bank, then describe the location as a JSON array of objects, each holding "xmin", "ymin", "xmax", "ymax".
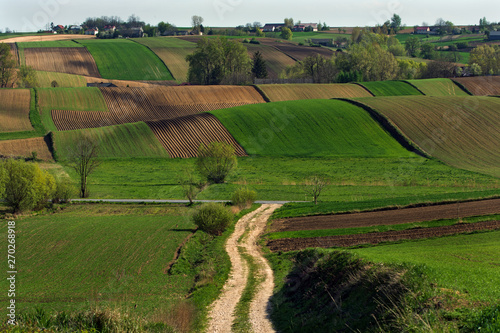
[{"xmin": 352, "ymin": 231, "xmax": 500, "ymax": 303}]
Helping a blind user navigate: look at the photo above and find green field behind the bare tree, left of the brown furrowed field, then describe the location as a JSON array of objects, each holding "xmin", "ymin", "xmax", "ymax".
[{"xmin": 54, "ymin": 122, "xmax": 168, "ymax": 160}]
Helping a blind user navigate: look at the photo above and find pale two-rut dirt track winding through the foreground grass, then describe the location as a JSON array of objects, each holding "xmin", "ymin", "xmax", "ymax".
[{"xmin": 207, "ymin": 204, "xmax": 281, "ymax": 333}]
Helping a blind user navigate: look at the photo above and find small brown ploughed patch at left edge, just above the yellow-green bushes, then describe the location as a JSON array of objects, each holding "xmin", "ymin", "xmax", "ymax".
[{"xmin": 0, "ymin": 138, "xmax": 52, "ymax": 161}]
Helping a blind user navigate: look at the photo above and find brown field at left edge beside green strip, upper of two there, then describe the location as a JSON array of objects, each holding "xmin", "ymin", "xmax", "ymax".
[{"xmin": 0, "ymin": 89, "xmax": 33, "ymax": 132}]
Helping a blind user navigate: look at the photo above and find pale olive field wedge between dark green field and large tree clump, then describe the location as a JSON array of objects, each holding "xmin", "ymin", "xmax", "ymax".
[{"xmin": 134, "ymin": 37, "xmax": 196, "ymax": 82}]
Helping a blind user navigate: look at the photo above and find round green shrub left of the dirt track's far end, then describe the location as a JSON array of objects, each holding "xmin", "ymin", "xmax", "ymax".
[{"xmin": 193, "ymin": 202, "xmax": 233, "ymax": 236}]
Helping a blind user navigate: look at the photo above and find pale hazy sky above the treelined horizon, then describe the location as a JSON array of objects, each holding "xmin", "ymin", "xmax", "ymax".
[{"xmin": 0, "ymin": 0, "xmax": 500, "ymax": 32}]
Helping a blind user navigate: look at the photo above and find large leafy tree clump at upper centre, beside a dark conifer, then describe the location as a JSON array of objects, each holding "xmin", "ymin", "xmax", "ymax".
[{"xmin": 186, "ymin": 37, "xmax": 251, "ymax": 85}]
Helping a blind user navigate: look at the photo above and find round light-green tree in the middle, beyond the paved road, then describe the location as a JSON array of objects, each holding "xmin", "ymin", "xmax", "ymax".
[{"xmin": 196, "ymin": 142, "xmax": 238, "ymax": 184}]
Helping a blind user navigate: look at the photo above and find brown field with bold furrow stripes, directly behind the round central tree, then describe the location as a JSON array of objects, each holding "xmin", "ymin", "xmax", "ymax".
[{"xmin": 146, "ymin": 113, "xmax": 247, "ymax": 158}]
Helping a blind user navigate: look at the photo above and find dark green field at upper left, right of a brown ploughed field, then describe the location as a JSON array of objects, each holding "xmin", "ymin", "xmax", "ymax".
[{"xmin": 79, "ymin": 39, "xmax": 173, "ymax": 81}]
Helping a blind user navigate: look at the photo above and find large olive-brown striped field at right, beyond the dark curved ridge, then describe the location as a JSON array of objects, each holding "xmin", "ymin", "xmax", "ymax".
[{"xmin": 359, "ymin": 96, "xmax": 500, "ymax": 177}]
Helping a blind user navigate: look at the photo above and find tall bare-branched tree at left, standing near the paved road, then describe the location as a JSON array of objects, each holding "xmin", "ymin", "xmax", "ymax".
[{"xmin": 68, "ymin": 135, "xmax": 100, "ymax": 198}]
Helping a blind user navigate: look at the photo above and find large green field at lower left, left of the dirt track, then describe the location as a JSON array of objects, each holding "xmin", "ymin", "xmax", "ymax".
[{"xmin": 1, "ymin": 205, "xmax": 194, "ymax": 318}]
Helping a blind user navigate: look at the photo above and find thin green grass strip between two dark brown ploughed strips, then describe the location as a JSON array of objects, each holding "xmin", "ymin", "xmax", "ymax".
[{"xmin": 266, "ymin": 214, "xmax": 500, "ymax": 239}]
